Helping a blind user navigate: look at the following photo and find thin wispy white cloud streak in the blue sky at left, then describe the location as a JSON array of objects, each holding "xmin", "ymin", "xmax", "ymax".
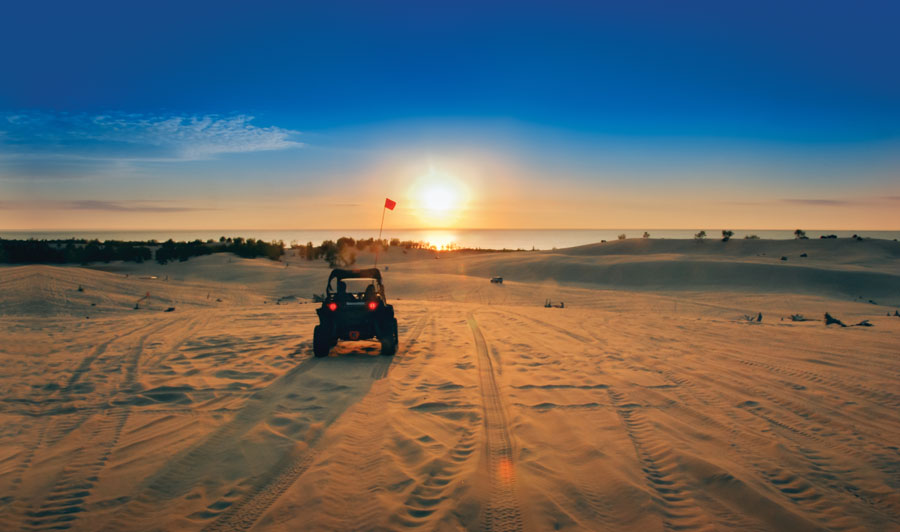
[{"xmin": 0, "ymin": 112, "xmax": 303, "ymax": 162}]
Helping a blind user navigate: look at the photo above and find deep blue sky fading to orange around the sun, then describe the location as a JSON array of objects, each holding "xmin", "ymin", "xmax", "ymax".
[{"xmin": 0, "ymin": 2, "xmax": 900, "ymax": 229}]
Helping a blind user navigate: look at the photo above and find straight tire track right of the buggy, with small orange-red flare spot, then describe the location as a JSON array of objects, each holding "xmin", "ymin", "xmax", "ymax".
[{"xmin": 466, "ymin": 312, "xmax": 522, "ymax": 531}]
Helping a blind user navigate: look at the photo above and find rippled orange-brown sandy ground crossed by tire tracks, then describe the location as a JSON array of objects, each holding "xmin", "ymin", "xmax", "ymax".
[{"xmin": 0, "ymin": 241, "xmax": 900, "ymax": 531}]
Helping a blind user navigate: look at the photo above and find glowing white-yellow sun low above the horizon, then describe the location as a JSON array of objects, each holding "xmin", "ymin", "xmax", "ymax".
[{"xmin": 410, "ymin": 169, "xmax": 468, "ymax": 227}]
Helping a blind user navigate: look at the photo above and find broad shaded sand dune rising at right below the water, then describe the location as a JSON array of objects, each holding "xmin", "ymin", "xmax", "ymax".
[{"xmin": 390, "ymin": 239, "xmax": 900, "ymax": 306}]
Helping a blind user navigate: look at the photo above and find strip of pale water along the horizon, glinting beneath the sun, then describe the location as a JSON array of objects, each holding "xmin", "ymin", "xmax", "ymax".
[{"xmin": 0, "ymin": 228, "xmax": 900, "ymax": 249}]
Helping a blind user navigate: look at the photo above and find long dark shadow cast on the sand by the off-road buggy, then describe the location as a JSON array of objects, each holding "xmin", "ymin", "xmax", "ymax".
[{"xmin": 106, "ymin": 348, "xmax": 394, "ymax": 530}]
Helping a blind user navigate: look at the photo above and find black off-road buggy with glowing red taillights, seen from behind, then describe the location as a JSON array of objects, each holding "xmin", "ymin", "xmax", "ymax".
[{"xmin": 313, "ymin": 268, "xmax": 398, "ymax": 357}]
